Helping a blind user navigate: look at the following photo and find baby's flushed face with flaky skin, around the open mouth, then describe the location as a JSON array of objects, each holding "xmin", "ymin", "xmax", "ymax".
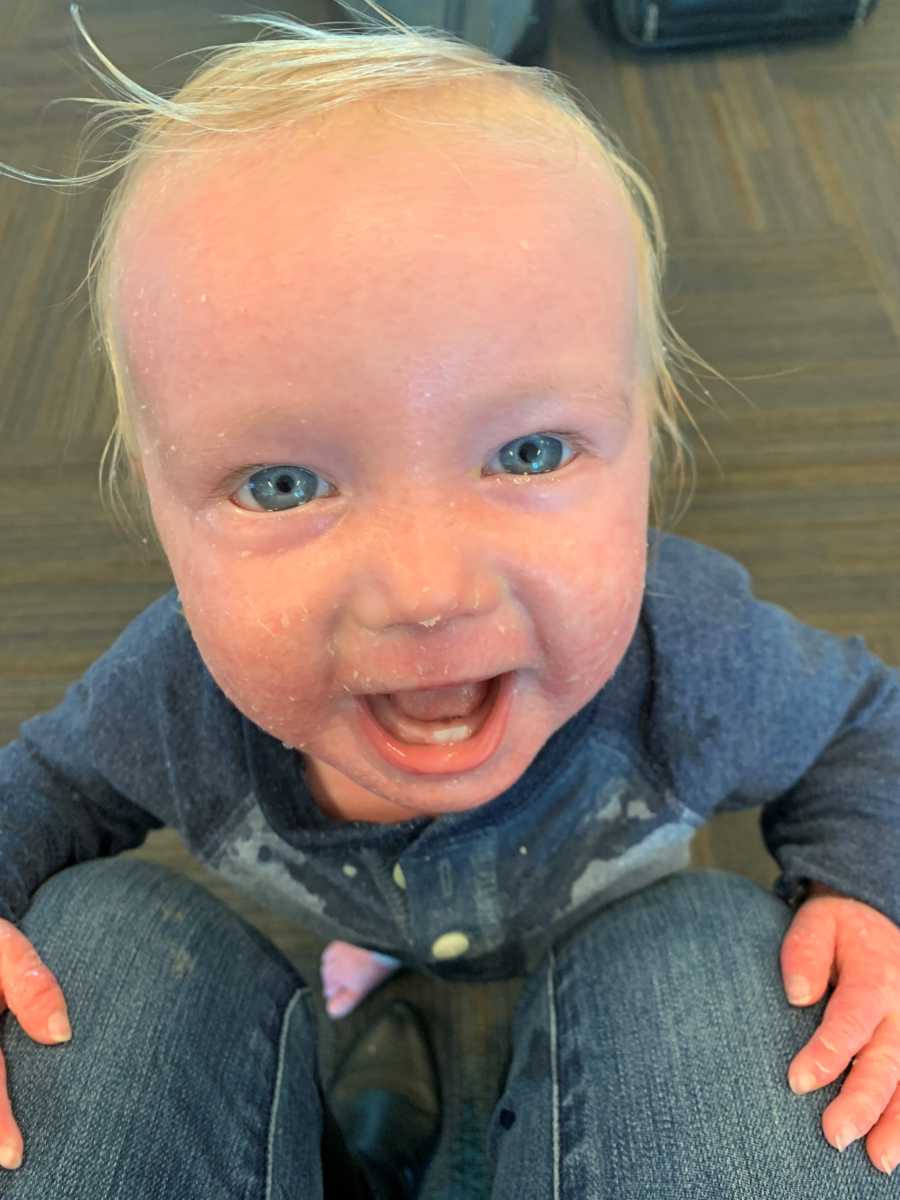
[{"xmin": 119, "ymin": 108, "xmax": 649, "ymax": 822}]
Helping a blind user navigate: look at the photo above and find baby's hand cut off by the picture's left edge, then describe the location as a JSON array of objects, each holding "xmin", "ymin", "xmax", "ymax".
[{"xmin": 0, "ymin": 918, "xmax": 72, "ymax": 1168}]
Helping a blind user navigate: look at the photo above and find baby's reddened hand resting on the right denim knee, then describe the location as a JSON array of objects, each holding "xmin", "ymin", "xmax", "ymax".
[{"xmin": 781, "ymin": 884, "xmax": 900, "ymax": 1174}]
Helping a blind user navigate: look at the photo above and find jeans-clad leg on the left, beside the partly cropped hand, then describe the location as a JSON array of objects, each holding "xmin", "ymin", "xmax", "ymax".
[{"xmin": 0, "ymin": 858, "xmax": 352, "ymax": 1200}]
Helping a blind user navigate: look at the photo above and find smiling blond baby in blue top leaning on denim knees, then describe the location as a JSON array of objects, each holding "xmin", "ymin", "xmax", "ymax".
[{"xmin": 0, "ymin": 0, "xmax": 900, "ymax": 1185}]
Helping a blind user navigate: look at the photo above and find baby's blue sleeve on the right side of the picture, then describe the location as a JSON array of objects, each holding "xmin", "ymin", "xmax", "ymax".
[{"xmin": 648, "ymin": 535, "xmax": 900, "ymax": 924}]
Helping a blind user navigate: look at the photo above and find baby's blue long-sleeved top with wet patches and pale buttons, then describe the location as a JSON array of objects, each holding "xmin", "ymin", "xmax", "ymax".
[{"xmin": 0, "ymin": 529, "xmax": 900, "ymax": 979}]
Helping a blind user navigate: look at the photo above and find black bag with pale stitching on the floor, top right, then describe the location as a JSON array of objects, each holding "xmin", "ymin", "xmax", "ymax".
[{"xmin": 600, "ymin": 0, "xmax": 878, "ymax": 50}]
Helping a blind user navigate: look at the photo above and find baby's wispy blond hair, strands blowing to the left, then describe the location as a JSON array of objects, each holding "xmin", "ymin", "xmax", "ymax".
[{"xmin": 0, "ymin": 0, "xmax": 727, "ymax": 550}]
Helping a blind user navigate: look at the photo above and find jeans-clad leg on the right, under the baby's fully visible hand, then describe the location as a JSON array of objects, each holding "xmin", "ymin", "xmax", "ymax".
[{"xmin": 487, "ymin": 870, "xmax": 900, "ymax": 1200}]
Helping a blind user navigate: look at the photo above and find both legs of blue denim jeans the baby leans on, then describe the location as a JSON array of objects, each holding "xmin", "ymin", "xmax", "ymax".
[{"xmin": 0, "ymin": 858, "xmax": 900, "ymax": 1200}]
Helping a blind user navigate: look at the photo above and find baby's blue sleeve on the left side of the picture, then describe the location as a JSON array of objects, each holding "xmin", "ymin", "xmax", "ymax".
[{"xmin": 0, "ymin": 601, "xmax": 184, "ymax": 922}]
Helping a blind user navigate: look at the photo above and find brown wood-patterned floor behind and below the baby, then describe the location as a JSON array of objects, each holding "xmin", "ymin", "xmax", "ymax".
[{"xmin": 0, "ymin": 0, "xmax": 900, "ymax": 1200}]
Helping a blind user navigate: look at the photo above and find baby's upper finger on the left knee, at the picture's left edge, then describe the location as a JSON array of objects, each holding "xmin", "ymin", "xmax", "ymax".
[{"xmin": 0, "ymin": 920, "xmax": 72, "ymax": 1043}]
